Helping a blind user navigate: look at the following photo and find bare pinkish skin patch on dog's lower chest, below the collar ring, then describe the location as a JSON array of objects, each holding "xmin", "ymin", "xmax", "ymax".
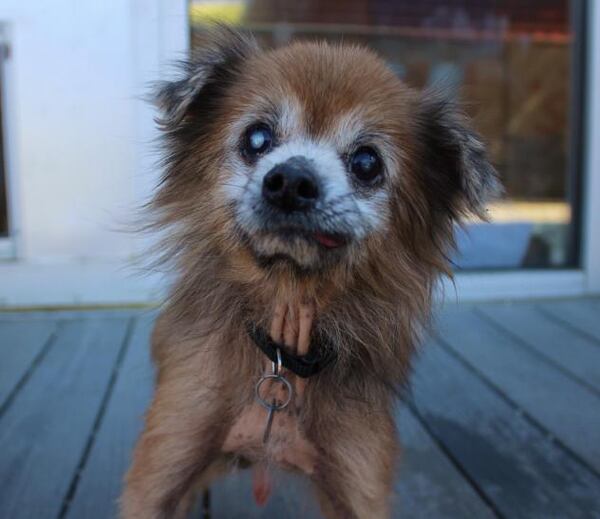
[{"xmin": 223, "ymin": 402, "xmax": 317, "ymax": 474}]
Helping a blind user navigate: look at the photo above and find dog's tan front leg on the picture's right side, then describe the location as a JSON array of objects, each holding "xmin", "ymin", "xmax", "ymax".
[{"xmin": 312, "ymin": 408, "xmax": 399, "ymax": 519}]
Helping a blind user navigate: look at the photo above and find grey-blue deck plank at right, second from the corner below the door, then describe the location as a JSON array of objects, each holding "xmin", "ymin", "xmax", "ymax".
[{"xmin": 478, "ymin": 303, "xmax": 600, "ymax": 392}]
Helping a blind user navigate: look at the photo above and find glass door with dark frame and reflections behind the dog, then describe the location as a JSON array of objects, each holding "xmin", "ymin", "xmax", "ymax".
[{"xmin": 190, "ymin": 0, "xmax": 585, "ymax": 270}]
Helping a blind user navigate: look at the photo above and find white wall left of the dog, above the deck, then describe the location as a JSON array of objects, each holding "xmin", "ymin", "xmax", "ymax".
[{"xmin": 0, "ymin": 0, "xmax": 187, "ymax": 304}]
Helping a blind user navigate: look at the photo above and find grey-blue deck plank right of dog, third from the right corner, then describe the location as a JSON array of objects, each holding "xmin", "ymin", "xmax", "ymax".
[{"xmin": 438, "ymin": 309, "xmax": 600, "ymax": 473}]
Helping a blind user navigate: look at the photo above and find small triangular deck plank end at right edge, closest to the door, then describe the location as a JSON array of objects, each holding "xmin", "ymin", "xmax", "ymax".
[{"xmin": 538, "ymin": 299, "xmax": 600, "ymax": 345}]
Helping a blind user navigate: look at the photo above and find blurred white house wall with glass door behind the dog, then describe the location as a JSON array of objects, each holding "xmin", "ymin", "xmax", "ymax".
[{"xmin": 0, "ymin": 0, "xmax": 600, "ymax": 305}]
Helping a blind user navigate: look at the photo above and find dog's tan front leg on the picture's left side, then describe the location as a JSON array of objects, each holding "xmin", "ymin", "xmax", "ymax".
[{"xmin": 121, "ymin": 377, "xmax": 227, "ymax": 519}]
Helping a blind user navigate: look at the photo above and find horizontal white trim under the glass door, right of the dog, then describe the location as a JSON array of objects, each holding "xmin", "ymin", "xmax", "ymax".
[{"xmin": 438, "ymin": 270, "xmax": 586, "ymax": 302}]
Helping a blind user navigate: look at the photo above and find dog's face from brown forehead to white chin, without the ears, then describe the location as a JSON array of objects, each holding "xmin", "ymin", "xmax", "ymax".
[{"xmin": 221, "ymin": 45, "xmax": 418, "ymax": 271}]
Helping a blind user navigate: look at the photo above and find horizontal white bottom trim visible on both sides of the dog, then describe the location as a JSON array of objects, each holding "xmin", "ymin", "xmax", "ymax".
[{"xmin": 0, "ymin": 262, "xmax": 586, "ymax": 307}]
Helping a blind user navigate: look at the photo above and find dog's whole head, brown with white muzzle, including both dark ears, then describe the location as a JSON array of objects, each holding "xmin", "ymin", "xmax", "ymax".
[{"xmin": 158, "ymin": 30, "xmax": 496, "ymax": 282}]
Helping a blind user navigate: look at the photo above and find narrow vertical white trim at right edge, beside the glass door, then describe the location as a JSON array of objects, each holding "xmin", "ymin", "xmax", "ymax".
[{"xmin": 582, "ymin": 2, "xmax": 600, "ymax": 293}]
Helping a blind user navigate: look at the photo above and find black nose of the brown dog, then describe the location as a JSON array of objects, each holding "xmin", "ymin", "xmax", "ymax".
[{"xmin": 262, "ymin": 157, "xmax": 319, "ymax": 212}]
